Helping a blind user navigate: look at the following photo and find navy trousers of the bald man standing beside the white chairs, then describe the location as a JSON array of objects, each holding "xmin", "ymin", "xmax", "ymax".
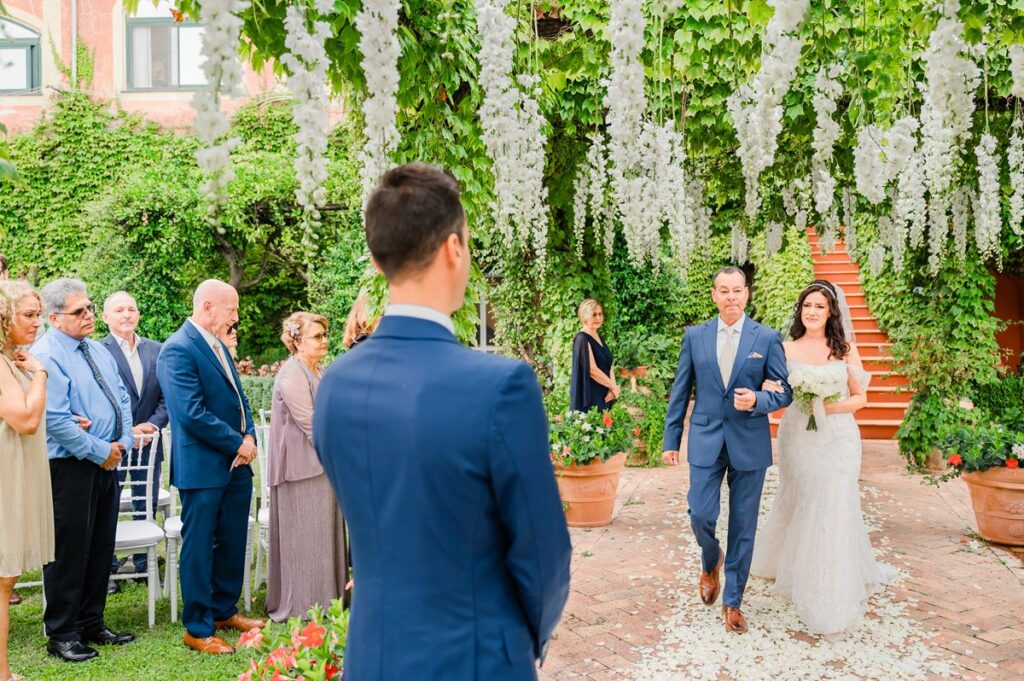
[{"xmin": 178, "ymin": 466, "xmax": 253, "ymax": 638}]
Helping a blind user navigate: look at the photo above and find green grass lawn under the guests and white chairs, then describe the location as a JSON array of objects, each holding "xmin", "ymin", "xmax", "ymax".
[{"xmin": 10, "ymin": 571, "xmax": 274, "ymax": 681}]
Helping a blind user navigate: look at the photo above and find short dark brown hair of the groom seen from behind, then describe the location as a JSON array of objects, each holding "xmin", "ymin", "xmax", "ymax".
[{"xmin": 365, "ymin": 163, "xmax": 466, "ymax": 281}]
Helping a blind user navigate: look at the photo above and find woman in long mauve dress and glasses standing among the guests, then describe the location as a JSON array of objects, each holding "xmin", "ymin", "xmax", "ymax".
[{"xmin": 266, "ymin": 312, "xmax": 348, "ymax": 622}]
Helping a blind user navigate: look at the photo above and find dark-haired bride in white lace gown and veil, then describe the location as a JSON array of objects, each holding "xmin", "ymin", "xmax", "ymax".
[{"xmin": 751, "ymin": 281, "xmax": 896, "ymax": 638}]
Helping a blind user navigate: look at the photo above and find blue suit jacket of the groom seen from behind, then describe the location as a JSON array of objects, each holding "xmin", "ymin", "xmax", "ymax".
[{"xmin": 313, "ymin": 316, "xmax": 570, "ymax": 681}]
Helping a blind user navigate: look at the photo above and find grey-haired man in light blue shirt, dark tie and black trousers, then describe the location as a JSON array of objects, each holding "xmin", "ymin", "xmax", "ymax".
[{"xmin": 32, "ymin": 279, "xmax": 134, "ymax": 662}]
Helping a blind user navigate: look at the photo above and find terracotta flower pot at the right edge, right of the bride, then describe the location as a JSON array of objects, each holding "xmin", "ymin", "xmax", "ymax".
[{"xmin": 964, "ymin": 466, "xmax": 1024, "ymax": 546}]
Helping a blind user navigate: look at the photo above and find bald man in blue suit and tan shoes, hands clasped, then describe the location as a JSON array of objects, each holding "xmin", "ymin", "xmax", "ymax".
[{"xmin": 157, "ymin": 280, "xmax": 265, "ymax": 654}]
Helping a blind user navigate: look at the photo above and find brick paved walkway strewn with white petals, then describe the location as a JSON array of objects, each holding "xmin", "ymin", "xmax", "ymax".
[{"xmin": 541, "ymin": 441, "xmax": 1024, "ymax": 681}]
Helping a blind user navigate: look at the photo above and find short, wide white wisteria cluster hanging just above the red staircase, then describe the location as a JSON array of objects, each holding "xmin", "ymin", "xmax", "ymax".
[{"xmin": 853, "ymin": 116, "xmax": 918, "ymax": 205}]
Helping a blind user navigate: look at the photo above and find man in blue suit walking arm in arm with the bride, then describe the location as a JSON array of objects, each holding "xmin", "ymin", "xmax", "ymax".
[{"xmin": 663, "ymin": 267, "xmax": 793, "ymax": 634}]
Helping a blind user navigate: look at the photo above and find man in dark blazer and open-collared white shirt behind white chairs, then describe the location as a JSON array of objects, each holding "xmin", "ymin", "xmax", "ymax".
[{"xmin": 99, "ymin": 291, "xmax": 167, "ymax": 584}]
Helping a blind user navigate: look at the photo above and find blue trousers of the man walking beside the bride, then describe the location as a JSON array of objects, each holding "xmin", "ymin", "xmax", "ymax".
[{"xmin": 686, "ymin": 446, "xmax": 765, "ymax": 607}]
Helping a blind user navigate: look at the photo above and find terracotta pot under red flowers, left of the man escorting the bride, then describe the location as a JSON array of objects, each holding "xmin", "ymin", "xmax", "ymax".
[{"xmin": 555, "ymin": 452, "xmax": 626, "ymax": 527}]
